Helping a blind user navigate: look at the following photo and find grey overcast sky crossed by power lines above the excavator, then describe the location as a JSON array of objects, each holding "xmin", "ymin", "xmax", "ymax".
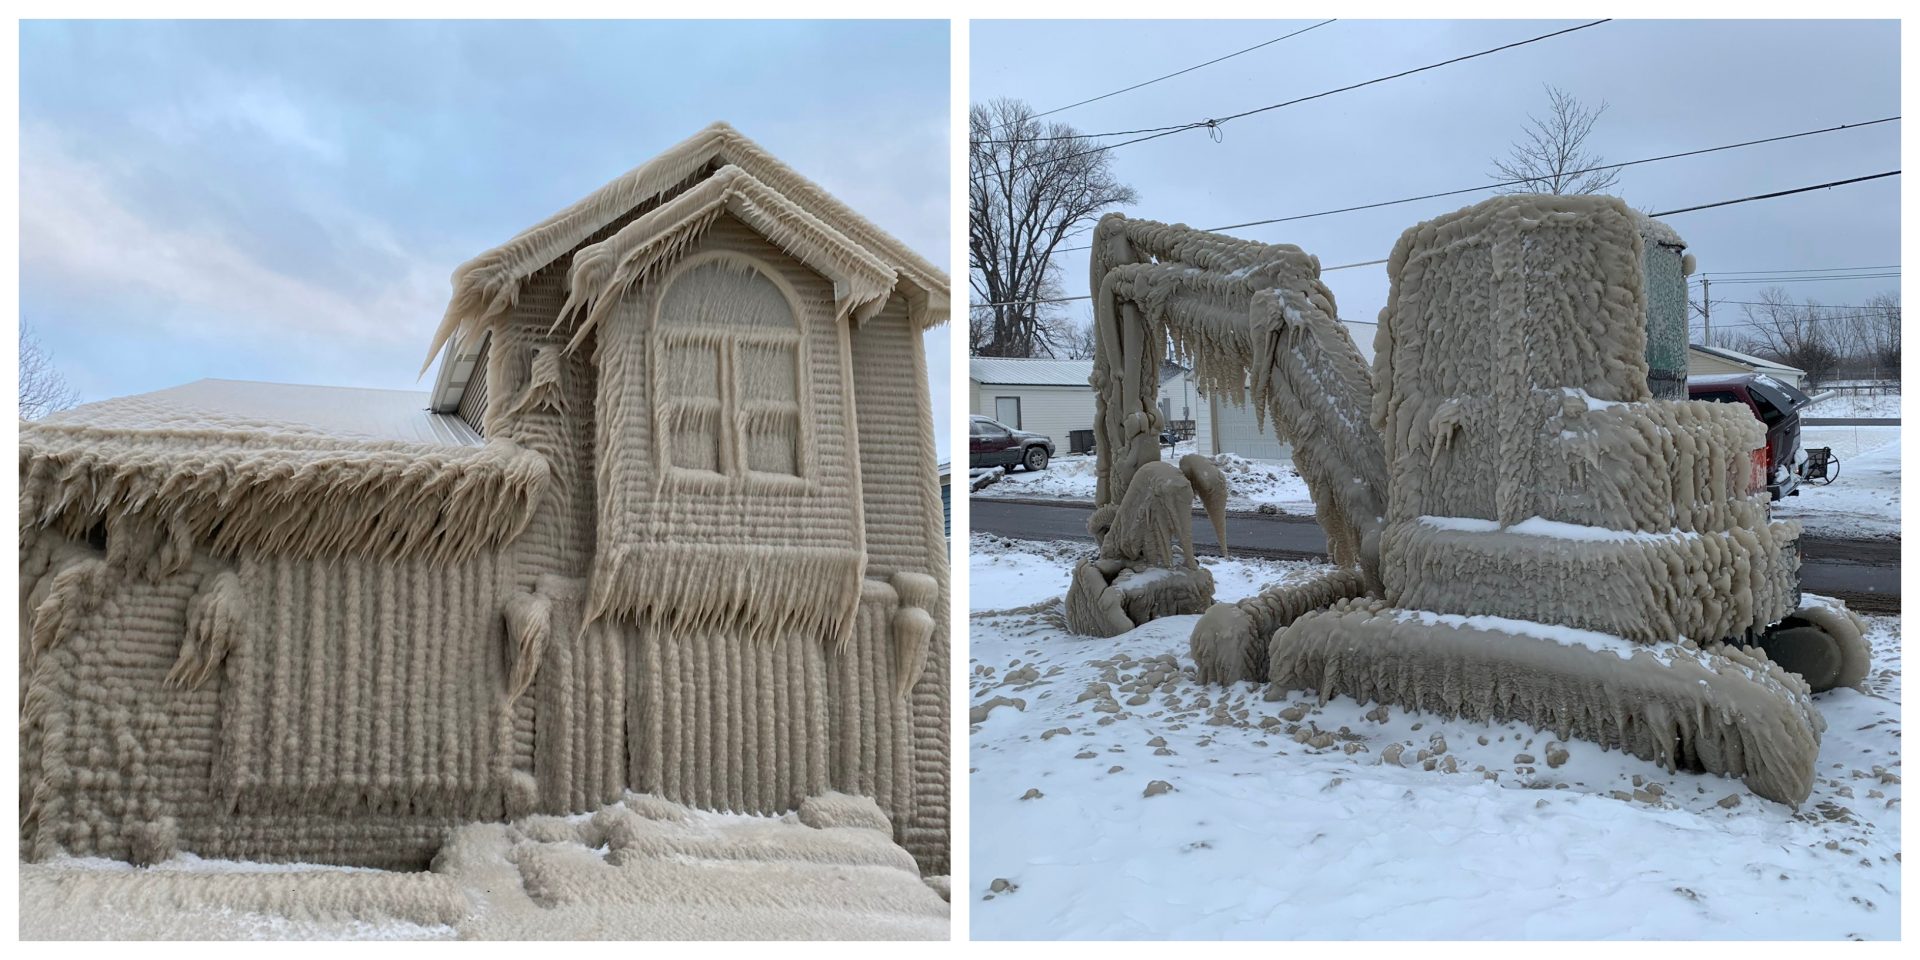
[{"xmin": 970, "ymin": 19, "xmax": 1901, "ymax": 357}]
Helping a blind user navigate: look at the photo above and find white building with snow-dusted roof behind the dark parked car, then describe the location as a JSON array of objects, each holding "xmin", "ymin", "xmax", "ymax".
[{"xmin": 968, "ymin": 357, "xmax": 1213, "ymax": 453}]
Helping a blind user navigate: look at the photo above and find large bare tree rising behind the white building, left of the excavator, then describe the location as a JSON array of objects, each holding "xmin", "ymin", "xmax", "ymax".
[{"xmin": 968, "ymin": 100, "xmax": 1137, "ymax": 357}]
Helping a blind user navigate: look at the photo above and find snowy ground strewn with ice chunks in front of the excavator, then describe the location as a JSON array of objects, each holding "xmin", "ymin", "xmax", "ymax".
[{"xmin": 962, "ymin": 536, "xmax": 1901, "ymax": 939}]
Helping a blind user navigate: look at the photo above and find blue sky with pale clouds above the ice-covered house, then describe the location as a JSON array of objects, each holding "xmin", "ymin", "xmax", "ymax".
[{"xmin": 19, "ymin": 21, "xmax": 950, "ymax": 457}]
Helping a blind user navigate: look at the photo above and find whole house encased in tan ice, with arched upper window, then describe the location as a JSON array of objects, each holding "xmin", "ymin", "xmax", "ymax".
[{"xmin": 19, "ymin": 125, "xmax": 950, "ymax": 874}]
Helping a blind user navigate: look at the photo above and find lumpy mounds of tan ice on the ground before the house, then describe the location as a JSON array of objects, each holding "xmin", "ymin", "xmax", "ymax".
[{"xmin": 21, "ymin": 793, "xmax": 947, "ymax": 939}]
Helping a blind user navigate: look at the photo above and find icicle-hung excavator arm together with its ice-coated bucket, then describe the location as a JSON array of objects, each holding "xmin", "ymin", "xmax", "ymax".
[{"xmin": 1068, "ymin": 213, "xmax": 1386, "ymax": 636}]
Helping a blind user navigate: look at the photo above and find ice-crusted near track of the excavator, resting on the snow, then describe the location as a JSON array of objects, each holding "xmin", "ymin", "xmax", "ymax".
[{"xmin": 1269, "ymin": 601, "xmax": 1826, "ymax": 804}]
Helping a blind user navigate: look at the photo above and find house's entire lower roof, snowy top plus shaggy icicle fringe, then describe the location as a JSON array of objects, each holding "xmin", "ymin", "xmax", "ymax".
[{"xmin": 19, "ymin": 380, "xmax": 551, "ymax": 564}]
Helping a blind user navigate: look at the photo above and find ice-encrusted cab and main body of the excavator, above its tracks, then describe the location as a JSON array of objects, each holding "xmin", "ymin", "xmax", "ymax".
[{"xmin": 1373, "ymin": 196, "xmax": 1797, "ymax": 641}]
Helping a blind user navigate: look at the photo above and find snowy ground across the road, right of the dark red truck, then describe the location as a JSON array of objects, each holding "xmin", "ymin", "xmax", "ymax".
[{"xmin": 1774, "ymin": 426, "xmax": 1901, "ymax": 538}]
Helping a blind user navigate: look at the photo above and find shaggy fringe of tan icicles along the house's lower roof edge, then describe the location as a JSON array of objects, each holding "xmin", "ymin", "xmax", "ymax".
[{"xmin": 21, "ymin": 422, "xmax": 551, "ymax": 560}]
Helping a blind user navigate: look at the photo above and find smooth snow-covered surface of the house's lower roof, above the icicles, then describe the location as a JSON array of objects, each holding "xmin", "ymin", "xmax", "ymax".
[{"xmin": 40, "ymin": 378, "xmax": 484, "ymax": 447}]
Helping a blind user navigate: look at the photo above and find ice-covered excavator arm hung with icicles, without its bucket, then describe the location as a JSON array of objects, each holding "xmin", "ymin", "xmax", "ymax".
[{"xmin": 1091, "ymin": 213, "xmax": 1386, "ymax": 589}]
